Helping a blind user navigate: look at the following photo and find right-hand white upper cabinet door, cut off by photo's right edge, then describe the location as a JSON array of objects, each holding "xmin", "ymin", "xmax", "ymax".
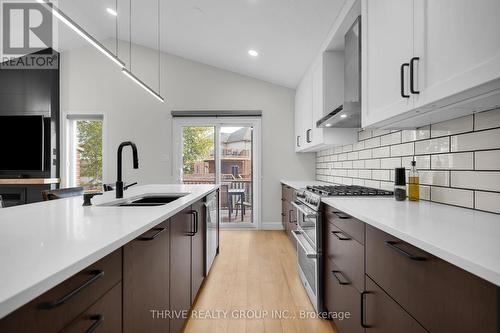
[{"xmin": 414, "ymin": 0, "xmax": 500, "ymax": 106}]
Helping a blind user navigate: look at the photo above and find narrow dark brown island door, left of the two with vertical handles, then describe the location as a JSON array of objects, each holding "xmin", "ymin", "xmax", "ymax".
[{"xmin": 170, "ymin": 207, "xmax": 194, "ymax": 333}]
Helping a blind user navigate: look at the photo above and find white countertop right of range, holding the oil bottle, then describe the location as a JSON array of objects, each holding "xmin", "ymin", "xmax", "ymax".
[{"xmin": 322, "ymin": 197, "xmax": 500, "ymax": 286}]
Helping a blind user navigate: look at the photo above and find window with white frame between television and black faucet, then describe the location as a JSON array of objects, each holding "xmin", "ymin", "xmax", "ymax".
[{"xmin": 67, "ymin": 115, "xmax": 103, "ymax": 190}]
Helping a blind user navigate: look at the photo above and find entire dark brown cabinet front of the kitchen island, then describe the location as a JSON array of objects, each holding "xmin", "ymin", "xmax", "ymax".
[{"xmin": 0, "ymin": 195, "xmax": 213, "ymax": 333}]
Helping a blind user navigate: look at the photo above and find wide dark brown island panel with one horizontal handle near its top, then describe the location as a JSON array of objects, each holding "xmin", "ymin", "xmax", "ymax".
[{"xmin": 123, "ymin": 221, "xmax": 170, "ymax": 333}]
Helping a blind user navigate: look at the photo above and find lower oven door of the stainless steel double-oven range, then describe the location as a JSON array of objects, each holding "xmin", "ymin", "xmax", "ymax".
[{"xmin": 292, "ymin": 230, "xmax": 321, "ymax": 312}]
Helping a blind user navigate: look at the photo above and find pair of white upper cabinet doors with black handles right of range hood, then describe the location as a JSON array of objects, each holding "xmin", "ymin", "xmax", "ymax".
[{"xmin": 362, "ymin": 0, "xmax": 500, "ymax": 128}]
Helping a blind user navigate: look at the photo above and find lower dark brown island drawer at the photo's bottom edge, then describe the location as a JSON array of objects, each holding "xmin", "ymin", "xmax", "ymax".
[{"xmin": 61, "ymin": 283, "xmax": 122, "ymax": 333}]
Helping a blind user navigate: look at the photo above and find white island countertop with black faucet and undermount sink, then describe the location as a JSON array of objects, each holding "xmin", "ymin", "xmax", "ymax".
[{"xmin": 0, "ymin": 185, "xmax": 218, "ymax": 318}]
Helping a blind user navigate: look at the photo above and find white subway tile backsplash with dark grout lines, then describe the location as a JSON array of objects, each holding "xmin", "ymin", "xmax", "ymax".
[{"xmin": 316, "ymin": 109, "xmax": 500, "ymax": 214}]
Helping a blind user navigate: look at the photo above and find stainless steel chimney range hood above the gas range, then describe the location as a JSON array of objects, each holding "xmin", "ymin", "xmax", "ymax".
[{"xmin": 316, "ymin": 17, "xmax": 361, "ymax": 128}]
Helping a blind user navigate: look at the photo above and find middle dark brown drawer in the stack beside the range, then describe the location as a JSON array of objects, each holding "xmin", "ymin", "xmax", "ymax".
[{"xmin": 325, "ymin": 223, "xmax": 365, "ymax": 291}]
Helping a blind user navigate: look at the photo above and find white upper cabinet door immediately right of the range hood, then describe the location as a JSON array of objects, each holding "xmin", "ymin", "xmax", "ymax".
[{"xmin": 361, "ymin": 0, "xmax": 414, "ymax": 126}]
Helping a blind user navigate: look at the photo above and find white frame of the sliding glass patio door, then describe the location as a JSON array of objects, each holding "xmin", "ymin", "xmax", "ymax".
[{"xmin": 171, "ymin": 116, "xmax": 262, "ymax": 229}]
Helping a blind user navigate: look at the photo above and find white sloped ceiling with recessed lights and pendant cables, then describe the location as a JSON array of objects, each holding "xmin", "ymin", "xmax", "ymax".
[{"xmin": 54, "ymin": 0, "xmax": 345, "ymax": 88}]
